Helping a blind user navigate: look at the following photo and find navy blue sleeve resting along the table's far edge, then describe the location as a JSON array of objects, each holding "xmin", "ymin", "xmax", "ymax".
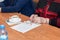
[{"xmin": 2, "ymin": 0, "xmax": 29, "ymax": 12}]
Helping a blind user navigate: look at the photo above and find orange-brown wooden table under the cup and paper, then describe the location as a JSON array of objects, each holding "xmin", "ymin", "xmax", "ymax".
[{"xmin": 0, "ymin": 13, "xmax": 60, "ymax": 40}]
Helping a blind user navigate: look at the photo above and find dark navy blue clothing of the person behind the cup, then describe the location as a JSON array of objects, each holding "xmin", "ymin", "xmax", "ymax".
[{"xmin": 2, "ymin": 0, "xmax": 34, "ymax": 16}]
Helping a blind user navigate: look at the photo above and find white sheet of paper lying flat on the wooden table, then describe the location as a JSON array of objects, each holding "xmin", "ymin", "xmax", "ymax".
[{"xmin": 11, "ymin": 22, "xmax": 41, "ymax": 33}]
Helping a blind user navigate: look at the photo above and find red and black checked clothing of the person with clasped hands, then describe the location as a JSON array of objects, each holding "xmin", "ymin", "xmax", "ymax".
[{"xmin": 35, "ymin": 0, "xmax": 60, "ymax": 28}]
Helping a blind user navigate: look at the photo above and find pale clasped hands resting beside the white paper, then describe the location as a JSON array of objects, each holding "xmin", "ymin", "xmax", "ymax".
[{"xmin": 30, "ymin": 14, "xmax": 49, "ymax": 24}]
